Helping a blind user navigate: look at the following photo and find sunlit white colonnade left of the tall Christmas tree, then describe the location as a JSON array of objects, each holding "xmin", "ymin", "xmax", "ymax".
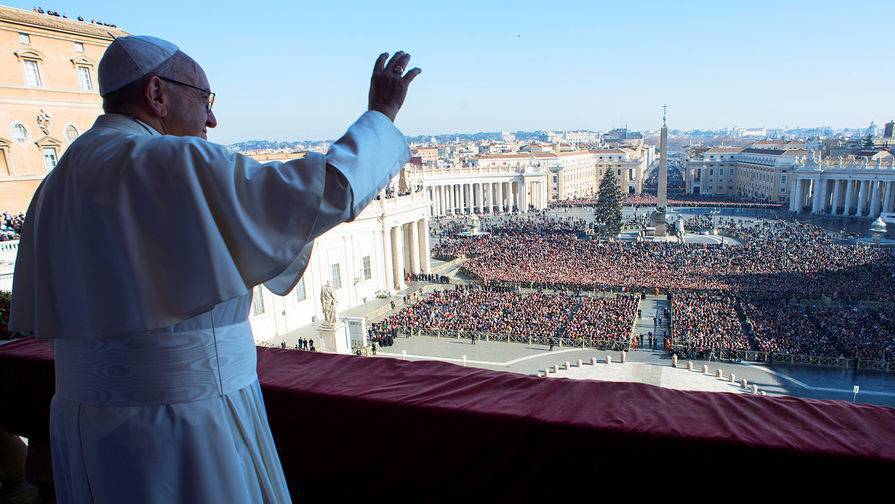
[{"xmin": 426, "ymin": 181, "xmax": 547, "ymax": 216}]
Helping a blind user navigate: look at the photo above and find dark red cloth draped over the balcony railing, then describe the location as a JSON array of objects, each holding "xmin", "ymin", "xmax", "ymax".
[{"xmin": 0, "ymin": 339, "xmax": 895, "ymax": 502}]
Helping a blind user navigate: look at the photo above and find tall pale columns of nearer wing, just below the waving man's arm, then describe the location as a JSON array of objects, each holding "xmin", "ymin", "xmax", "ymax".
[{"xmin": 382, "ymin": 219, "xmax": 432, "ymax": 291}]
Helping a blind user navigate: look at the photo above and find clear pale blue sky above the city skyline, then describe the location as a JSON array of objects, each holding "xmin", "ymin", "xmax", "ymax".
[{"xmin": 7, "ymin": 0, "xmax": 895, "ymax": 143}]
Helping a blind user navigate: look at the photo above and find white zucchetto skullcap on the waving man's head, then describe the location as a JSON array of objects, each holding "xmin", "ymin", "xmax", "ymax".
[{"xmin": 97, "ymin": 35, "xmax": 178, "ymax": 96}]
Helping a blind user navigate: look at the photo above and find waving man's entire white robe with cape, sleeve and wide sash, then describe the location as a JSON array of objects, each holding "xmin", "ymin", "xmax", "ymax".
[{"xmin": 10, "ymin": 112, "xmax": 410, "ymax": 503}]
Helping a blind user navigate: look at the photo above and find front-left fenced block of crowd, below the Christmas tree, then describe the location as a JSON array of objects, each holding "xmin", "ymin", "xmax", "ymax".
[{"xmin": 371, "ymin": 285, "xmax": 638, "ymax": 346}]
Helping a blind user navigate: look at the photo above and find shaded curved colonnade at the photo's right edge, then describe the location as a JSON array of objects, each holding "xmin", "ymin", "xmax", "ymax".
[{"xmin": 789, "ymin": 177, "xmax": 895, "ymax": 219}]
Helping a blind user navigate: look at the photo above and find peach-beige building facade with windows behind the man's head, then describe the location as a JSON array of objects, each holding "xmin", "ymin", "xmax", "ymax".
[{"xmin": 0, "ymin": 6, "xmax": 126, "ymax": 212}]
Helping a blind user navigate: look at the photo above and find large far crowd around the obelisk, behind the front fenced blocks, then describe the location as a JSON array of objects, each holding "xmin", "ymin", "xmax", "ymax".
[{"xmin": 434, "ymin": 221, "xmax": 895, "ymax": 299}]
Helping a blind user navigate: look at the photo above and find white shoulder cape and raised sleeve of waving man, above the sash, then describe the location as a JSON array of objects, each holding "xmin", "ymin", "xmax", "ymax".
[{"xmin": 10, "ymin": 112, "xmax": 410, "ymax": 338}]
